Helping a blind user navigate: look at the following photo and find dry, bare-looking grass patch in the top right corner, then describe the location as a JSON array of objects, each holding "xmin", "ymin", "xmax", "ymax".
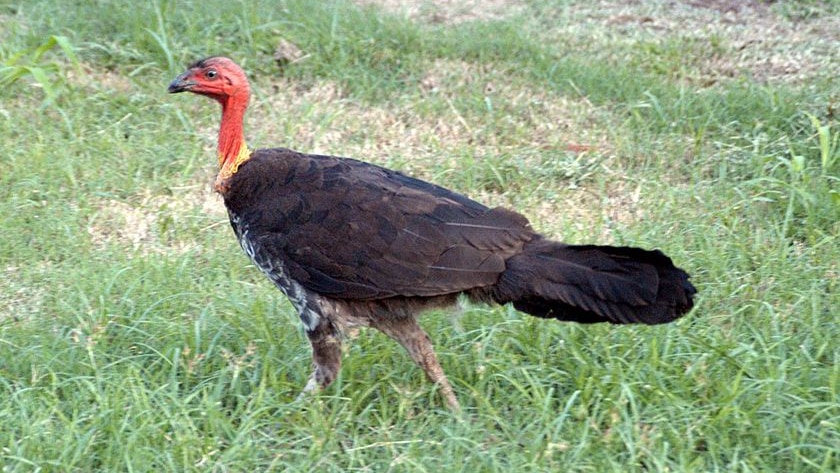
[{"xmin": 556, "ymin": 0, "xmax": 840, "ymax": 85}]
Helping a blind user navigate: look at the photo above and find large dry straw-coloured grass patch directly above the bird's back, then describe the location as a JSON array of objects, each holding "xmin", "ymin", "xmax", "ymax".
[{"xmin": 249, "ymin": 60, "xmax": 610, "ymax": 173}]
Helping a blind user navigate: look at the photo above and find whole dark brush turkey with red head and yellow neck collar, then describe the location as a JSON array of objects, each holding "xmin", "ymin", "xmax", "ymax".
[{"xmin": 168, "ymin": 56, "xmax": 697, "ymax": 411}]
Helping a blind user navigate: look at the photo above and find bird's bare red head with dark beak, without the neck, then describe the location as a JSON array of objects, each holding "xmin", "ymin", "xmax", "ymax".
[{"xmin": 169, "ymin": 57, "xmax": 251, "ymax": 105}]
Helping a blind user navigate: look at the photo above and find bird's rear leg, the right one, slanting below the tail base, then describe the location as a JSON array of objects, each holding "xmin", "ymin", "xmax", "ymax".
[{"xmin": 374, "ymin": 317, "xmax": 461, "ymax": 412}]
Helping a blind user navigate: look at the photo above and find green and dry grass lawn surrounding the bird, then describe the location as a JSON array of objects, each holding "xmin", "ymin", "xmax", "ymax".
[{"xmin": 0, "ymin": 0, "xmax": 840, "ymax": 472}]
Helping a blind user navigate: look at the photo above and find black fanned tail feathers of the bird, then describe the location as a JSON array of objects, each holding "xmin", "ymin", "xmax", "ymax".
[{"xmin": 491, "ymin": 239, "xmax": 697, "ymax": 324}]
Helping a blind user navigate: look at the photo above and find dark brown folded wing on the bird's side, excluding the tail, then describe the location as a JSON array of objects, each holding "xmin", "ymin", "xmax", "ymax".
[{"xmin": 225, "ymin": 149, "xmax": 535, "ymax": 299}]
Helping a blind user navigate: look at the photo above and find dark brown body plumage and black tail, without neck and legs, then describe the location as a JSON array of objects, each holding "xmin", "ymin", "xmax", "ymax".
[{"xmin": 224, "ymin": 149, "xmax": 695, "ymax": 324}]
